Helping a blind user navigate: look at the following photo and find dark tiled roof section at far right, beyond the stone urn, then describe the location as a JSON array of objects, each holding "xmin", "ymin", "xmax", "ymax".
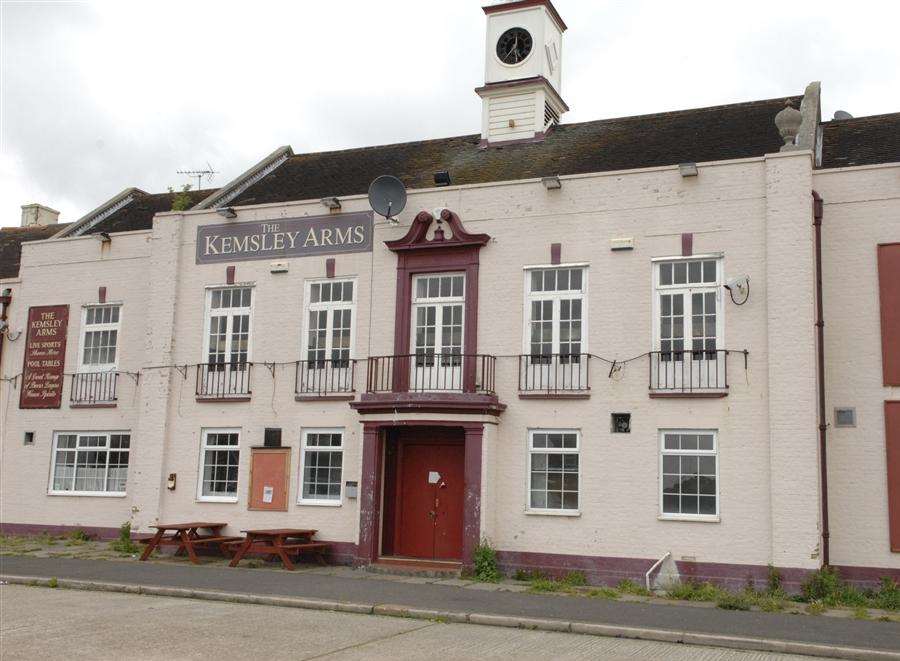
[{"xmin": 822, "ymin": 112, "xmax": 900, "ymax": 168}]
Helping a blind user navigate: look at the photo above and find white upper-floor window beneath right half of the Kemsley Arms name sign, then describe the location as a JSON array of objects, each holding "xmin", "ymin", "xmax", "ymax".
[{"xmin": 306, "ymin": 280, "xmax": 355, "ymax": 369}]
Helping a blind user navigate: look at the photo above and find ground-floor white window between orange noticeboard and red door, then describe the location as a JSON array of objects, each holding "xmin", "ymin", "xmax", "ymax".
[{"xmin": 299, "ymin": 429, "xmax": 344, "ymax": 505}]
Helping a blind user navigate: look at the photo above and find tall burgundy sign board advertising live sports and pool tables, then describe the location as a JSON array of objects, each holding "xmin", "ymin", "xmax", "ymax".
[{"xmin": 19, "ymin": 305, "xmax": 69, "ymax": 409}]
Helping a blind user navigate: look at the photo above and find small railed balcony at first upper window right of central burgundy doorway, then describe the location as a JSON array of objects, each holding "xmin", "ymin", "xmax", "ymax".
[{"xmin": 519, "ymin": 353, "xmax": 591, "ymax": 399}]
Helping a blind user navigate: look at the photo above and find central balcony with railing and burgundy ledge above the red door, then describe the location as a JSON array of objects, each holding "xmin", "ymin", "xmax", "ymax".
[{"xmin": 351, "ymin": 353, "xmax": 506, "ymax": 414}]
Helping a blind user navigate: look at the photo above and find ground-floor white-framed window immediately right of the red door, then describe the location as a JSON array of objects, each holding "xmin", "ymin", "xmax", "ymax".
[{"xmin": 528, "ymin": 429, "xmax": 580, "ymax": 512}]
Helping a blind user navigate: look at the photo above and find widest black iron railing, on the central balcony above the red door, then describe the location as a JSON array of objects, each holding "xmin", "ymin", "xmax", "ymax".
[{"xmin": 366, "ymin": 353, "xmax": 497, "ymax": 394}]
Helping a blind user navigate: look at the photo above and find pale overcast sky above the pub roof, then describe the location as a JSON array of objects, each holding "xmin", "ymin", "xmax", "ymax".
[{"xmin": 0, "ymin": 0, "xmax": 900, "ymax": 226}]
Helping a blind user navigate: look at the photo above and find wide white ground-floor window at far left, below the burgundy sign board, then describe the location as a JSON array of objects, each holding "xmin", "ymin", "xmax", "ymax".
[{"xmin": 50, "ymin": 432, "xmax": 131, "ymax": 495}]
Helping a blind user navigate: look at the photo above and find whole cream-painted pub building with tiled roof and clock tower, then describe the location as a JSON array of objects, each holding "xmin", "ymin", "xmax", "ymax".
[{"xmin": 0, "ymin": 0, "xmax": 900, "ymax": 588}]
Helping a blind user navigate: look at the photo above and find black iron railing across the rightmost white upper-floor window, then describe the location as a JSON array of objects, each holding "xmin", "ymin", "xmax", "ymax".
[{"xmin": 649, "ymin": 349, "xmax": 728, "ymax": 392}]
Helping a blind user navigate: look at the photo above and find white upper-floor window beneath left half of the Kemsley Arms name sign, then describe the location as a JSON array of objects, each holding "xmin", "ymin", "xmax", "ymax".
[{"xmin": 204, "ymin": 287, "xmax": 253, "ymax": 368}]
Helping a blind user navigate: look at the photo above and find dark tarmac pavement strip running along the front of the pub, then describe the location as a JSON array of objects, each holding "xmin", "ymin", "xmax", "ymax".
[{"xmin": 0, "ymin": 556, "xmax": 900, "ymax": 652}]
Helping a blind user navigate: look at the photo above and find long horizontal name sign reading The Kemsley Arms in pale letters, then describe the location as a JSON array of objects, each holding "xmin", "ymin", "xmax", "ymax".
[{"xmin": 197, "ymin": 211, "xmax": 373, "ymax": 264}]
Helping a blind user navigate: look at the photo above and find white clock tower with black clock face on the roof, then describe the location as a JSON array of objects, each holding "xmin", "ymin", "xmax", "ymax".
[{"xmin": 475, "ymin": 0, "xmax": 569, "ymax": 147}]
